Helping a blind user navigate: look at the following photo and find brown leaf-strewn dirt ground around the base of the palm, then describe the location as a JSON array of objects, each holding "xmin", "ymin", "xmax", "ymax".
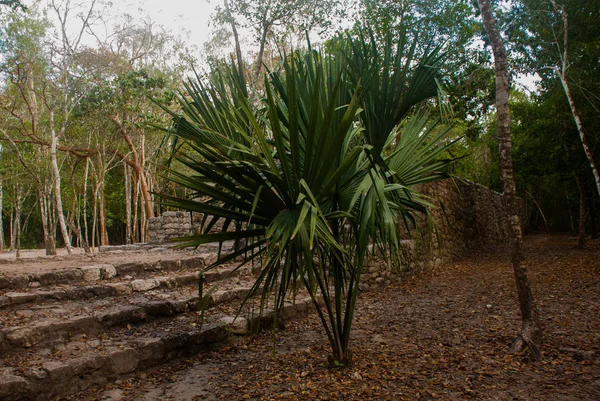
[{"xmin": 74, "ymin": 237, "xmax": 600, "ymax": 401}]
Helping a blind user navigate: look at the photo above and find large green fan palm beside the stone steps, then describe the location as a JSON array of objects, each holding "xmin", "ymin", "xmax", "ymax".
[{"xmin": 159, "ymin": 29, "xmax": 452, "ymax": 366}]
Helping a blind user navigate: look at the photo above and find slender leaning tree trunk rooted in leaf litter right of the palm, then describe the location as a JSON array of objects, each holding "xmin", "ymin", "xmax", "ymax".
[{"xmin": 478, "ymin": 0, "xmax": 542, "ymax": 360}]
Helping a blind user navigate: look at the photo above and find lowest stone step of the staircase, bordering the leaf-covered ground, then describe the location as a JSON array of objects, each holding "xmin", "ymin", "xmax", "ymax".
[{"xmin": 0, "ymin": 298, "xmax": 312, "ymax": 401}]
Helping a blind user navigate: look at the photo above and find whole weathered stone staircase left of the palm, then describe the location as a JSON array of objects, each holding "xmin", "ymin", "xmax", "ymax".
[{"xmin": 0, "ymin": 247, "xmax": 312, "ymax": 401}]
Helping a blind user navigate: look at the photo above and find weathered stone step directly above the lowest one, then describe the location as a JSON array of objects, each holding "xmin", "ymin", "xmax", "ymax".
[{"xmin": 0, "ymin": 277, "xmax": 254, "ymax": 351}]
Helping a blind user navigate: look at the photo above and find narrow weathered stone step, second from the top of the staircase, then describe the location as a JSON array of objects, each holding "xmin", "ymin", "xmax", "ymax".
[{"xmin": 0, "ymin": 266, "xmax": 251, "ymax": 311}]
